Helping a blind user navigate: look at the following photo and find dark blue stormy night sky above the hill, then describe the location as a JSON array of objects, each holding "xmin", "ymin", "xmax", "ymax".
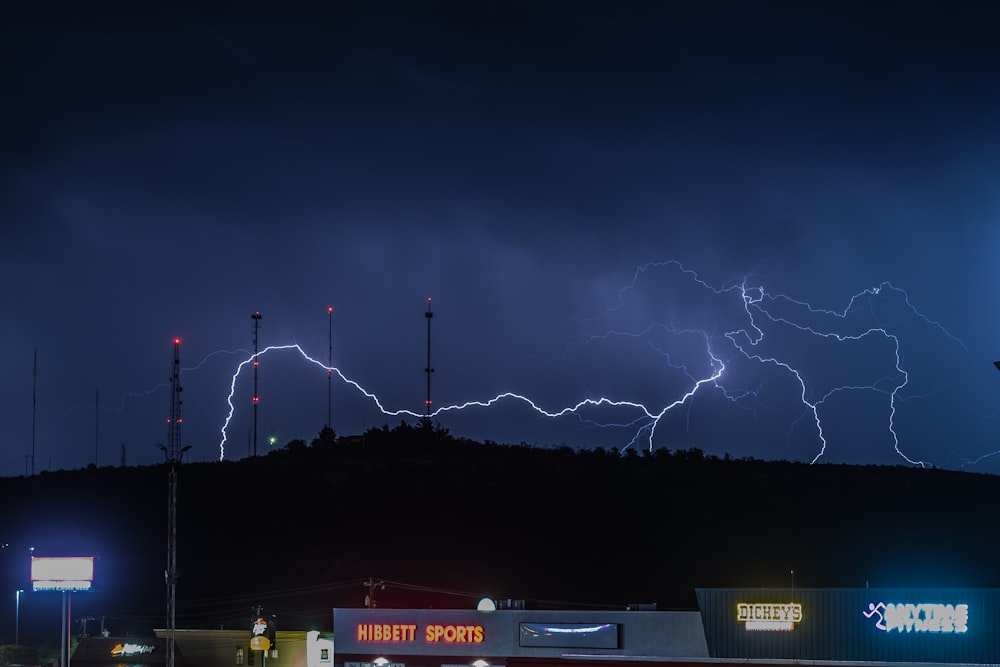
[{"xmin": 0, "ymin": 0, "xmax": 1000, "ymax": 476}]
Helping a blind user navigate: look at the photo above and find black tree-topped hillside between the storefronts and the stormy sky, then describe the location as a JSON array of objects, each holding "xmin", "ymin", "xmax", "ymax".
[{"xmin": 0, "ymin": 426, "xmax": 1000, "ymax": 641}]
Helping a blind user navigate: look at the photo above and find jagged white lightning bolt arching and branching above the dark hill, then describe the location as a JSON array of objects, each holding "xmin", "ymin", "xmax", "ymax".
[{"xmin": 219, "ymin": 260, "xmax": 965, "ymax": 467}]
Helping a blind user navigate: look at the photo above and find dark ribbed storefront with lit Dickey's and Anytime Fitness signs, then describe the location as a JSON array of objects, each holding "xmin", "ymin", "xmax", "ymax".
[{"xmin": 697, "ymin": 588, "xmax": 1000, "ymax": 664}]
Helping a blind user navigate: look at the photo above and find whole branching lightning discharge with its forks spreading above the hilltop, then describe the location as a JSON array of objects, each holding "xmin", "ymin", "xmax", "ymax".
[{"xmin": 219, "ymin": 261, "xmax": 965, "ymax": 467}]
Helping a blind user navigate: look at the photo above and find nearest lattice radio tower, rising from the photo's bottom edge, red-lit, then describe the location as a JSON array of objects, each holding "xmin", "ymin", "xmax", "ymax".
[{"xmin": 160, "ymin": 338, "xmax": 190, "ymax": 667}]
